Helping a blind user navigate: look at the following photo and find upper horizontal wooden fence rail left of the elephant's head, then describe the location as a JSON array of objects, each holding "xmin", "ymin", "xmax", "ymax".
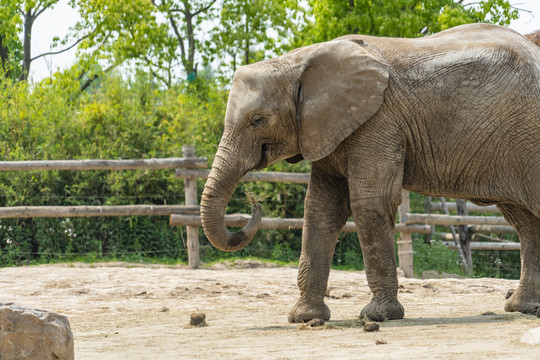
[{"xmin": 0, "ymin": 158, "xmax": 208, "ymax": 171}]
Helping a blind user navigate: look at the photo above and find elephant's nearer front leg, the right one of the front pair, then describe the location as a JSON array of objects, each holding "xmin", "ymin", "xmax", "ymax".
[{"xmin": 350, "ymin": 177, "xmax": 404, "ymax": 319}]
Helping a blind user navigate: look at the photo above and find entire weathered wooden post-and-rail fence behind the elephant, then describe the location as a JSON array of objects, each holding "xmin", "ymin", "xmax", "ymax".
[{"xmin": 0, "ymin": 146, "xmax": 519, "ymax": 277}]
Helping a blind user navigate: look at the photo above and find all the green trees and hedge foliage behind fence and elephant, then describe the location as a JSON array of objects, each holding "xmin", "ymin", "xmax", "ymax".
[{"xmin": 0, "ymin": 0, "xmax": 519, "ymax": 278}]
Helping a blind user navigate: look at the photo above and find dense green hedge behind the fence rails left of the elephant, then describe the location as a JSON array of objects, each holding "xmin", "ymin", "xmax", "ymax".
[{"xmin": 0, "ymin": 73, "xmax": 226, "ymax": 265}]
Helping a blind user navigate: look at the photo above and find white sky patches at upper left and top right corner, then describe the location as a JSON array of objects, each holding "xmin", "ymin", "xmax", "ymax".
[{"xmin": 30, "ymin": 0, "xmax": 540, "ymax": 81}]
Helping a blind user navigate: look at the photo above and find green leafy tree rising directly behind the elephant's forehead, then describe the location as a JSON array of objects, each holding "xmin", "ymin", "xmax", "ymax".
[{"xmin": 209, "ymin": 0, "xmax": 302, "ymax": 71}]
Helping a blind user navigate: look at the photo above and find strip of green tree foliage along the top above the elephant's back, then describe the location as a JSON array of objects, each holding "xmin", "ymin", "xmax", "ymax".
[{"xmin": 302, "ymin": 0, "xmax": 518, "ymax": 43}]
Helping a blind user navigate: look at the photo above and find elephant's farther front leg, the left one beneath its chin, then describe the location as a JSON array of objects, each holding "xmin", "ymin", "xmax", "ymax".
[{"xmin": 289, "ymin": 164, "xmax": 350, "ymax": 322}]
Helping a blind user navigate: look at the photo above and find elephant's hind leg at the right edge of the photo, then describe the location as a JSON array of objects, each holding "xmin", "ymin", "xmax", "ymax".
[{"xmin": 497, "ymin": 204, "xmax": 540, "ymax": 313}]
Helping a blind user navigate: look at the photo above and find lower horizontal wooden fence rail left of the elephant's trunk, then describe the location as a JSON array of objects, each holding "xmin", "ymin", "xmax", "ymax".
[{"xmin": 0, "ymin": 205, "xmax": 200, "ymax": 218}]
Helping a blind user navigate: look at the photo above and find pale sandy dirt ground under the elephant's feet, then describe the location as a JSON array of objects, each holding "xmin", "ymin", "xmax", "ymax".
[{"xmin": 0, "ymin": 261, "xmax": 540, "ymax": 360}]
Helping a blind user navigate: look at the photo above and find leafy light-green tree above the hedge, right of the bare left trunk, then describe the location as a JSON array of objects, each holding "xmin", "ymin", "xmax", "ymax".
[{"xmin": 71, "ymin": 0, "xmax": 169, "ymax": 90}]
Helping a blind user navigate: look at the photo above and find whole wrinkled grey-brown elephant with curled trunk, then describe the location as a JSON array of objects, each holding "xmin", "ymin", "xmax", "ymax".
[{"xmin": 201, "ymin": 24, "xmax": 540, "ymax": 322}]
